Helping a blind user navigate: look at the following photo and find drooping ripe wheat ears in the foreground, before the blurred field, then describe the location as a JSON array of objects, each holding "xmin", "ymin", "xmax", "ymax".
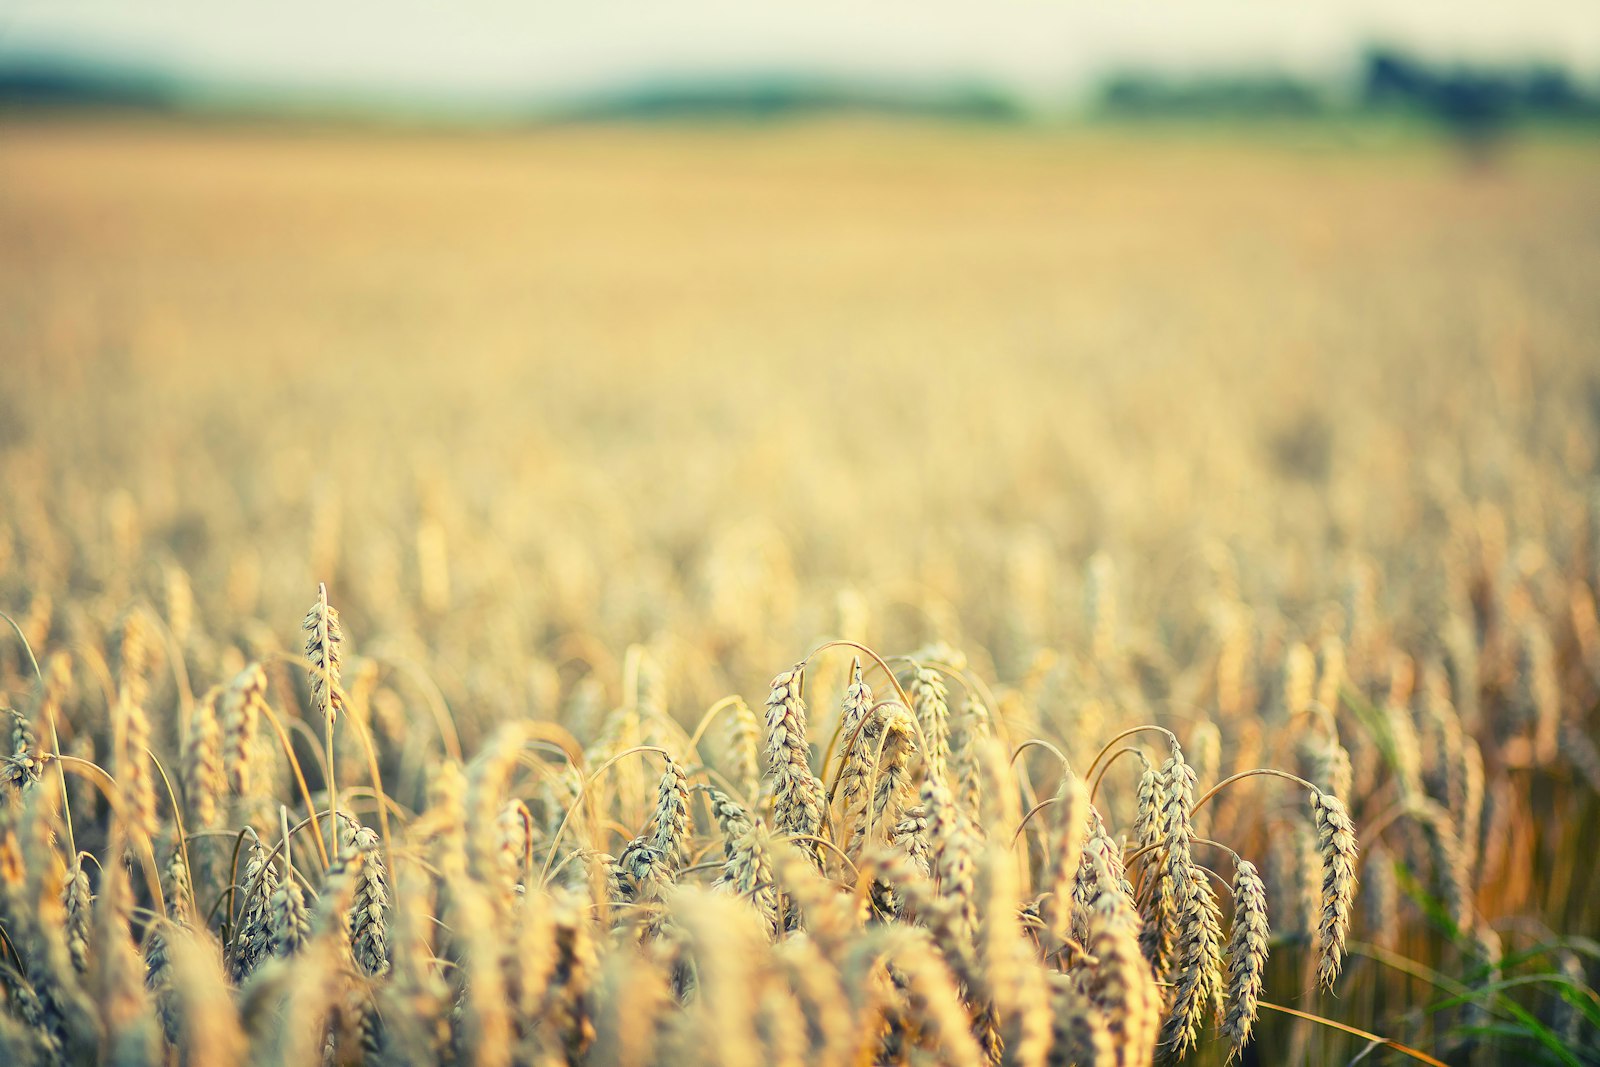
[{"xmin": 0, "ymin": 592, "xmax": 1382, "ymax": 1067}]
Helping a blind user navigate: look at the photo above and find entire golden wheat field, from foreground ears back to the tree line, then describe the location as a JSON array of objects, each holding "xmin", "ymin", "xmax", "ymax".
[{"xmin": 0, "ymin": 118, "xmax": 1600, "ymax": 1067}]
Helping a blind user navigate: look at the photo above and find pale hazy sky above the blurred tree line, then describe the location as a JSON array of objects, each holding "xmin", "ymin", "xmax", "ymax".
[{"xmin": 0, "ymin": 0, "xmax": 1600, "ymax": 101}]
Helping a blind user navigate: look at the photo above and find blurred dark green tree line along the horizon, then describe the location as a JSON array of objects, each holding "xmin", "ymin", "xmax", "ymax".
[{"xmin": 0, "ymin": 46, "xmax": 1600, "ymax": 129}]
